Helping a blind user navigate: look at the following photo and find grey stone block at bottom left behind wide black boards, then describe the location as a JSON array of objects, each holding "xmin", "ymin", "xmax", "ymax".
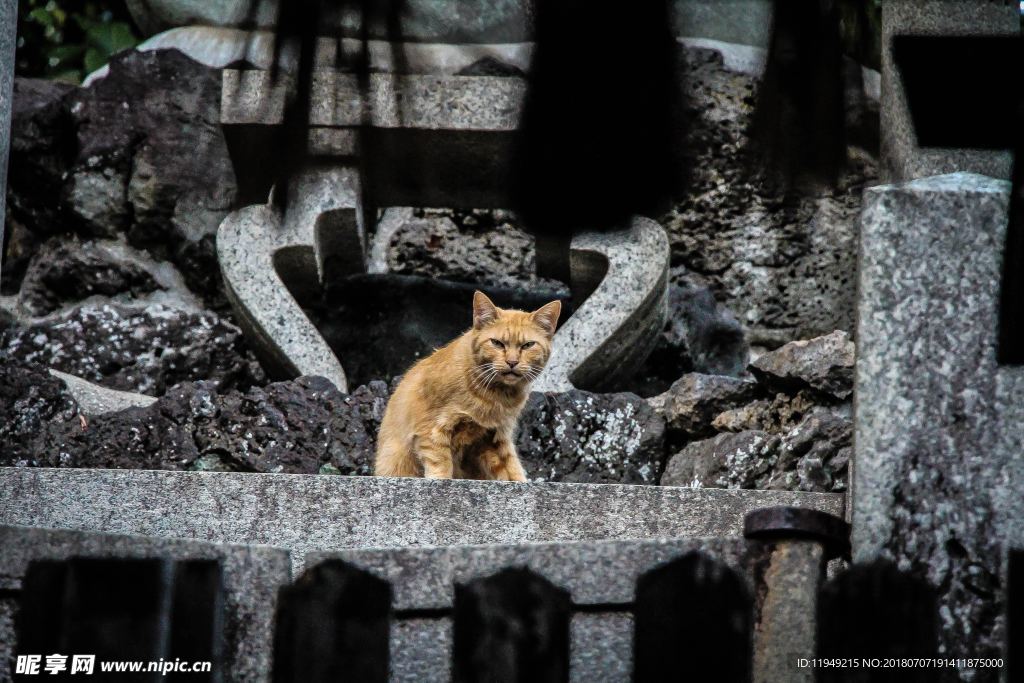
[{"xmin": 0, "ymin": 526, "xmax": 291, "ymax": 681}]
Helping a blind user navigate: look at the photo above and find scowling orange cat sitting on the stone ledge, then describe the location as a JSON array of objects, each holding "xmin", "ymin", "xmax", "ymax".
[{"xmin": 374, "ymin": 292, "xmax": 562, "ymax": 481}]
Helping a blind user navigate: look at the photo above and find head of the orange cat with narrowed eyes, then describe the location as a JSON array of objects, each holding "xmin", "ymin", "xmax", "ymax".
[{"xmin": 471, "ymin": 292, "xmax": 562, "ymax": 387}]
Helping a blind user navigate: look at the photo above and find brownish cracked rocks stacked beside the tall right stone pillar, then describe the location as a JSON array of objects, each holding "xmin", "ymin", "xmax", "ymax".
[{"xmin": 650, "ymin": 332, "xmax": 854, "ymax": 492}]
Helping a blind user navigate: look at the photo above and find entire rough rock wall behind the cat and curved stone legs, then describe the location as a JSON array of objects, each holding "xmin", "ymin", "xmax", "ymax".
[{"xmin": 0, "ymin": 42, "xmax": 873, "ymax": 490}]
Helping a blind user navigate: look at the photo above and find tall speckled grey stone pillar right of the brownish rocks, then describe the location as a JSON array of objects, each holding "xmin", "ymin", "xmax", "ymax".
[{"xmin": 852, "ymin": 173, "xmax": 1024, "ymax": 667}]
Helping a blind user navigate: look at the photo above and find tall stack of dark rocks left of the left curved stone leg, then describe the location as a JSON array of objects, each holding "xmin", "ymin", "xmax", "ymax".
[{"xmin": 0, "ymin": 50, "xmax": 266, "ymax": 396}]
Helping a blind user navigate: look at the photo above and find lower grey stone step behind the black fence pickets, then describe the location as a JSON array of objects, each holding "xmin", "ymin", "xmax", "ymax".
[{"xmin": 0, "ymin": 526, "xmax": 823, "ymax": 682}]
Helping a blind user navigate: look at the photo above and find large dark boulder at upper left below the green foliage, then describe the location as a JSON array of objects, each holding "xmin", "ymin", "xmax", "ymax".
[{"xmin": 10, "ymin": 50, "xmax": 236, "ymax": 307}]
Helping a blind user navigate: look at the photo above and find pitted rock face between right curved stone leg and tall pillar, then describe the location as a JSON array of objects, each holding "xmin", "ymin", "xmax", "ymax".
[{"xmin": 659, "ymin": 46, "xmax": 878, "ymax": 347}]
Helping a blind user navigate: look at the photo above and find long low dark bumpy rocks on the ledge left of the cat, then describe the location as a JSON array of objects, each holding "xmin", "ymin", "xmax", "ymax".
[{"xmin": 0, "ymin": 362, "xmax": 387, "ymax": 474}]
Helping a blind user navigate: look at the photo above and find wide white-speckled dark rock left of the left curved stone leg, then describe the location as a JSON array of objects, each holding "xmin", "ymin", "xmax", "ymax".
[{"xmin": 0, "ymin": 304, "xmax": 266, "ymax": 396}]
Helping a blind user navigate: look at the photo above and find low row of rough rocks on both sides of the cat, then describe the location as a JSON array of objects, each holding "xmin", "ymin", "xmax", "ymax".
[{"xmin": 0, "ymin": 332, "xmax": 853, "ymax": 490}]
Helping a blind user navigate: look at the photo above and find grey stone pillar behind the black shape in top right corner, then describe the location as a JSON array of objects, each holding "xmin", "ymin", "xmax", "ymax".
[{"xmin": 881, "ymin": 0, "xmax": 1020, "ymax": 182}]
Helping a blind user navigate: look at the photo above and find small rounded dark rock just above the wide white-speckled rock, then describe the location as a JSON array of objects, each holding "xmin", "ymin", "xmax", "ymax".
[{"xmin": 18, "ymin": 239, "xmax": 161, "ymax": 315}]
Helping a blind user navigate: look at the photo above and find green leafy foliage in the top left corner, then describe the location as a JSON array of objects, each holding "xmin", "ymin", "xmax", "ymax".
[{"xmin": 15, "ymin": 0, "xmax": 138, "ymax": 83}]
